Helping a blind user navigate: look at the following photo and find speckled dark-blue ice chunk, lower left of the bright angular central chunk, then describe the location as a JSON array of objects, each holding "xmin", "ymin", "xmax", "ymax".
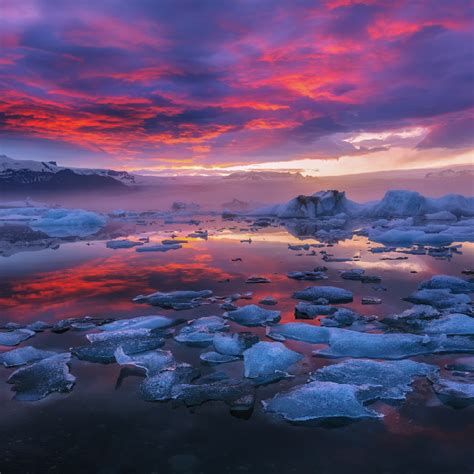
[{"xmin": 139, "ymin": 364, "xmax": 199, "ymax": 401}]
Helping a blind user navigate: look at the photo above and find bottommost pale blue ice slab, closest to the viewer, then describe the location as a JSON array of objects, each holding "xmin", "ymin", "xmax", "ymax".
[{"xmin": 262, "ymin": 381, "xmax": 382, "ymax": 422}]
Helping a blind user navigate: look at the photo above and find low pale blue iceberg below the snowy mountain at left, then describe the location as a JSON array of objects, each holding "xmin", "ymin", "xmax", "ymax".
[{"xmin": 29, "ymin": 209, "xmax": 107, "ymax": 237}]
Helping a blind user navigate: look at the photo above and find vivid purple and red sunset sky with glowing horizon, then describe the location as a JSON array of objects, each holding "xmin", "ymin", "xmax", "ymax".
[{"xmin": 0, "ymin": 0, "xmax": 474, "ymax": 175}]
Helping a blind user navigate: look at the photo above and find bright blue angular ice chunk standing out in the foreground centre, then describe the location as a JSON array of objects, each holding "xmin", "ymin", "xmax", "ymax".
[{"xmin": 244, "ymin": 342, "xmax": 303, "ymax": 378}]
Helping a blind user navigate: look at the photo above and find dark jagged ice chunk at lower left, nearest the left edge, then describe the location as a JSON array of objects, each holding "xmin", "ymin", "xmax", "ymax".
[{"xmin": 7, "ymin": 353, "xmax": 76, "ymax": 401}]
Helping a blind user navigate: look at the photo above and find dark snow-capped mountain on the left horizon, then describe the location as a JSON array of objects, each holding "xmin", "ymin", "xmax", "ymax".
[{"xmin": 0, "ymin": 155, "xmax": 135, "ymax": 191}]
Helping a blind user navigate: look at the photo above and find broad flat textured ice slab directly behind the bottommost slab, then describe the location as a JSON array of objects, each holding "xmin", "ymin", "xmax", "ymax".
[{"xmin": 310, "ymin": 359, "xmax": 438, "ymax": 401}]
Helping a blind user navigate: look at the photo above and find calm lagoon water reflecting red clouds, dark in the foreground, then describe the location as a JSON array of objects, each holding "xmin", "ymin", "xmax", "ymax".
[{"xmin": 0, "ymin": 221, "xmax": 474, "ymax": 474}]
